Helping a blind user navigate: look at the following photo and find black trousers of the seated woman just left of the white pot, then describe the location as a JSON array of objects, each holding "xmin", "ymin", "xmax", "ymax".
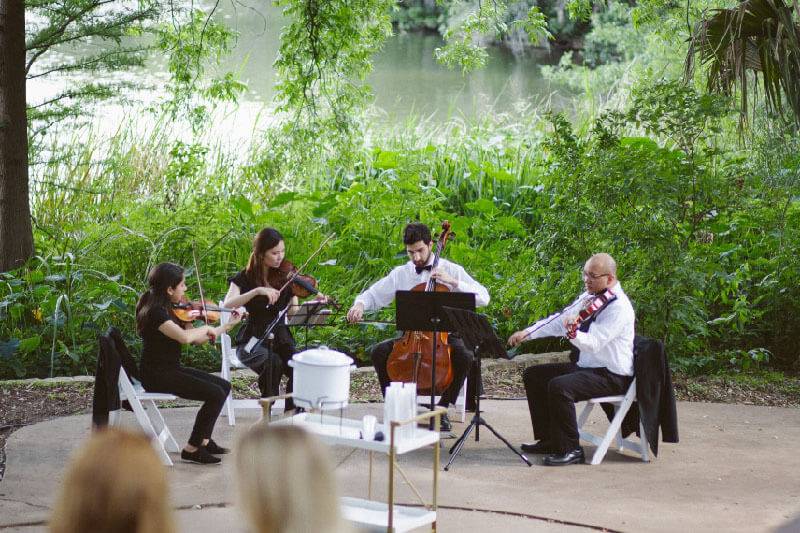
[{"xmin": 241, "ymin": 339, "xmax": 297, "ymax": 409}]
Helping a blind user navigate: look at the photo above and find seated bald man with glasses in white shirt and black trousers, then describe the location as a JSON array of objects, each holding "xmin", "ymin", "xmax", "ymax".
[{"xmin": 508, "ymin": 253, "xmax": 636, "ymax": 466}]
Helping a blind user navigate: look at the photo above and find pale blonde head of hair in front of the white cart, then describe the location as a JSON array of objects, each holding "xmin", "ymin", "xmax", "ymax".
[{"xmin": 236, "ymin": 424, "xmax": 349, "ymax": 533}]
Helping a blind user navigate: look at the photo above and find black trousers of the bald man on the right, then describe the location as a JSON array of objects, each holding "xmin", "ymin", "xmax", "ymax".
[{"xmin": 522, "ymin": 363, "xmax": 633, "ymax": 453}]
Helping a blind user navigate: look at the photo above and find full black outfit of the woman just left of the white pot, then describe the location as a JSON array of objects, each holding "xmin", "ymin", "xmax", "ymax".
[{"xmin": 228, "ymin": 270, "xmax": 297, "ymax": 409}]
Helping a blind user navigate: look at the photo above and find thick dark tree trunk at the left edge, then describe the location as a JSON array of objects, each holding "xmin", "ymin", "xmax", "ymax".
[{"xmin": 0, "ymin": 0, "xmax": 33, "ymax": 272}]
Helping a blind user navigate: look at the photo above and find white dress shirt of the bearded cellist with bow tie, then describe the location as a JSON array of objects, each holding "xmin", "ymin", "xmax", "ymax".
[{"xmin": 355, "ymin": 257, "xmax": 489, "ymax": 311}]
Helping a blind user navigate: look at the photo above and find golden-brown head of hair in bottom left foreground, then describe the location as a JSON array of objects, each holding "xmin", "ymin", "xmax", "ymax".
[{"xmin": 50, "ymin": 428, "xmax": 174, "ymax": 533}]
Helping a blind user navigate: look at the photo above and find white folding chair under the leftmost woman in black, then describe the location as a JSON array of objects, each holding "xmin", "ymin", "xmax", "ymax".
[{"xmin": 109, "ymin": 367, "xmax": 180, "ymax": 466}]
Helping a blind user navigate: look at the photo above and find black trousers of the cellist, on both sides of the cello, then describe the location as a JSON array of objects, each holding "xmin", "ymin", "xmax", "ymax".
[{"xmin": 370, "ymin": 334, "xmax": 478, "ymax": 410}]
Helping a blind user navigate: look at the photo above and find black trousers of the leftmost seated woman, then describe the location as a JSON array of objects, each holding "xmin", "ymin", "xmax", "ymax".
[{"xmin": 142, "ymin": 366, "xmax": 231, "ymax": 446}]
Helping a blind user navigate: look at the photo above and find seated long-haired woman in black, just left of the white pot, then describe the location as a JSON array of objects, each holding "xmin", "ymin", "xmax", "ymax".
[{"xmin": 223, "ymin": 228, "xmax": 325, "ymax": 410}]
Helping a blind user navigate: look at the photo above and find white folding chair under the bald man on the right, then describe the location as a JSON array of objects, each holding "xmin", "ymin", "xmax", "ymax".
[{"xmin": 578, "ymin": 378, "xmax": 650, "ymax": 465}]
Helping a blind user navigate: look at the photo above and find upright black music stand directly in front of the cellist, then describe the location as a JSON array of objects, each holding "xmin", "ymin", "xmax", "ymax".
[{"xmin": 395, "ymin": 291, "xmax": 475, "ymax": 430}]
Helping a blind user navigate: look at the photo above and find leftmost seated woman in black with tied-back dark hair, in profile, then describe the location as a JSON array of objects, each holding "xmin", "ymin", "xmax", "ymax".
[{"xmin": 136, "ymin": 263, "xmax": 241, "ymax": 464}]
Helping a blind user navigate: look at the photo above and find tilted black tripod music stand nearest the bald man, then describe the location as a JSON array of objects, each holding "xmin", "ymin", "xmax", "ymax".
[{"xmin": 442, "ymin": 307, "xmax": 532, "ymax": 470}]
